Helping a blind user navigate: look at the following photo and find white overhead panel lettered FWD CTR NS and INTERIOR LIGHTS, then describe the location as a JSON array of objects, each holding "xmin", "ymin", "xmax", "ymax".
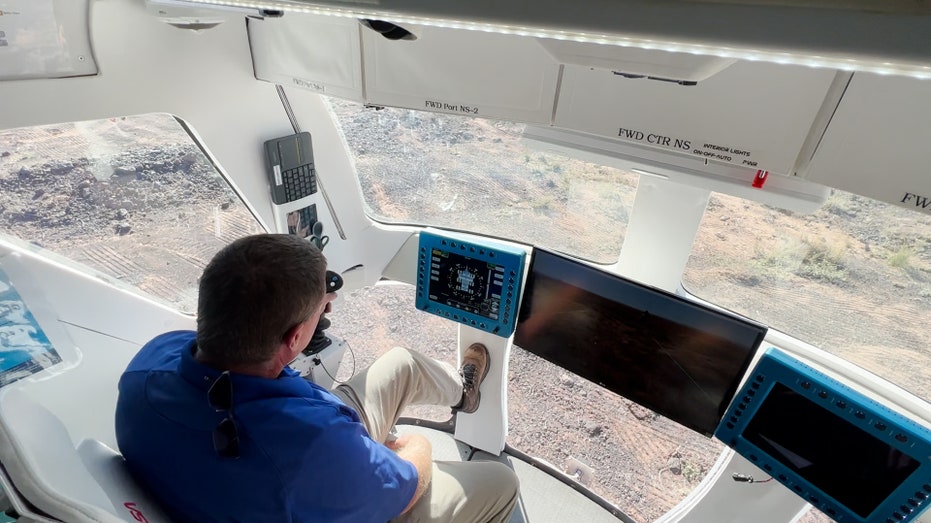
[{"xmin": 555, "ymin": 62, "xmax": 835, "ymax": 174}]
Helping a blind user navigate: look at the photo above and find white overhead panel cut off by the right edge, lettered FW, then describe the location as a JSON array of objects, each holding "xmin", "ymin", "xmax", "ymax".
[{"xmin": 805, "ymin": 73, "xmax": 931, "ymax": 213}]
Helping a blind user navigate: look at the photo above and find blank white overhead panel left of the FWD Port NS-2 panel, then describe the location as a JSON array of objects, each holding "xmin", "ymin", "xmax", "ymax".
[{"xmin": 249, "ymin": 13, "xmax": 362, "ymax": 101}]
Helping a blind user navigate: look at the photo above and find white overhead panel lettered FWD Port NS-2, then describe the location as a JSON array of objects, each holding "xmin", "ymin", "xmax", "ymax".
[{"xmin": 362, "ymin": 25, "xmax": 559, "ymax": 124}]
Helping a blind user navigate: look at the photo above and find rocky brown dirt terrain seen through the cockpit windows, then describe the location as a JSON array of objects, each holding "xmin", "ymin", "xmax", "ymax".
[{"xmin": 0, "ymin": 109, "xmax": 931, "ymax": 522}]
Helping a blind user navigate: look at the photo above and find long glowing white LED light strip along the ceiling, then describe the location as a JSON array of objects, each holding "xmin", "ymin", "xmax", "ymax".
[{"xmin": 171, "ymin": 0, "xmax": 931, "ymax": 79}]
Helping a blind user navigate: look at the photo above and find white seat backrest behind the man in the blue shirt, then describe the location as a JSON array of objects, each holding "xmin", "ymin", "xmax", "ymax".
[{"xmin": 0, "ymin": 388, "xmax": 169, "ymax": 523}]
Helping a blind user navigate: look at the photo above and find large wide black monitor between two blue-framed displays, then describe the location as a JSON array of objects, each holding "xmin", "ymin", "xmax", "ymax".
[{"xmin": 514, "ymin": 249, "xmax": 766, "ymax": 436}]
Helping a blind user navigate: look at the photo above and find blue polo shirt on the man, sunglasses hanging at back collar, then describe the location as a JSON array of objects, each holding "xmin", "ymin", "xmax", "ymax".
[{"xmin": 116, "ymin": 331, "xmax": 417, "ymax": 523}]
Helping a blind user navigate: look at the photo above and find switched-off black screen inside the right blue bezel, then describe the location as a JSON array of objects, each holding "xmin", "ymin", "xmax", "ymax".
[{"xmin": 743, "ymin": 382, "xmax": 919, "ymax": 518}]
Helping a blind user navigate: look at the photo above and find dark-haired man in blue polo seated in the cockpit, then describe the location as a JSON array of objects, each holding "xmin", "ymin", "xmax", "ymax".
[{"xmin": 116, "ymin": 234, "xmax": 518, "ymax": 523}]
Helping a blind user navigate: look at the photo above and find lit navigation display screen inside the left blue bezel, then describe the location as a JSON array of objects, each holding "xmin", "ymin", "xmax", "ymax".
[{"xmin": 429, "ymin": 249, "xmax": 505, "ymax": 320}]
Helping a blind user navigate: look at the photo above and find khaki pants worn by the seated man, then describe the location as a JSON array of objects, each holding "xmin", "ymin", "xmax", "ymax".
[{"xmin": 333, "ymin": 347, "xmax": 518, "ymax": 523}]
